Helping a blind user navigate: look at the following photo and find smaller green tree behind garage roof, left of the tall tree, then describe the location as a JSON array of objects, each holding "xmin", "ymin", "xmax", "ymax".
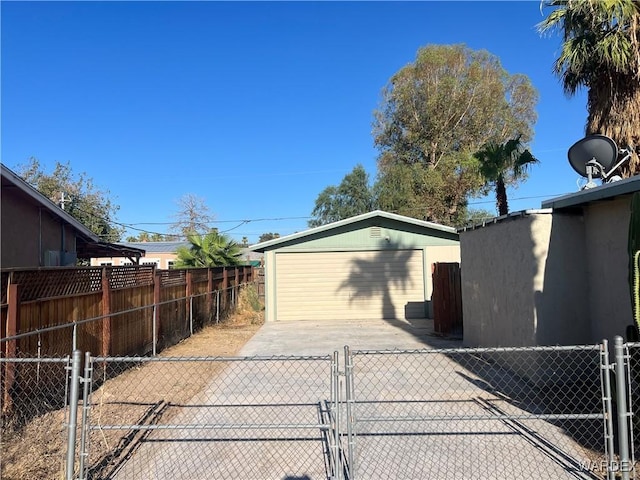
[{"xmin": 308, "ymin": 164, "xmax": 375, "ymax": 227}]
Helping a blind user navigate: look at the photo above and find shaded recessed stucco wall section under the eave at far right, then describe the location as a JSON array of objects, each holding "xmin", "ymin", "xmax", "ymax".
[{"xmin": 585, "ymin": 195, "xmax": 633, "ymax": 342}]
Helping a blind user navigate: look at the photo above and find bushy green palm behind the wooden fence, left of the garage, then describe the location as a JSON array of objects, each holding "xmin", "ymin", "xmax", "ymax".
[{"xmin": 176, "ymin": 230, "xmax": 242, "ymax": 268}]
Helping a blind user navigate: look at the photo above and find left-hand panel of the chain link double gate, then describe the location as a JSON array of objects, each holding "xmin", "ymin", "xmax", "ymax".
[{"xmin": 79, "ymin": 353, "xmax": 344, "ymax": 480}]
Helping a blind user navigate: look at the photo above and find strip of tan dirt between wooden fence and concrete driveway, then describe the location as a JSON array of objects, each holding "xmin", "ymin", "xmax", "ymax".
[{"xmin": 0, "ymin": 288, "xmax": 264, "ymax": 480}]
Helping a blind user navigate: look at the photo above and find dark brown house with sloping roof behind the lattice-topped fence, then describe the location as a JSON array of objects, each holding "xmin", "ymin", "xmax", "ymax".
[{"xmin": 0, "ymin": 164, "xmax": 144, "ymax": 268}]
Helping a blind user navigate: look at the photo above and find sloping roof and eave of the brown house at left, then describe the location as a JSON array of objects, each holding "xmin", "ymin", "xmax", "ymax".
[{"xmin": 0, "ymin": 163, "xmax": 144, "ymax": 258}]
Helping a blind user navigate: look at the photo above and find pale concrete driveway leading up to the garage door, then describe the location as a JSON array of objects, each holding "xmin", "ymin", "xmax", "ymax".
[{"xmin": 107, "ymin": 320, "xmax": 604, "ymax": 480}]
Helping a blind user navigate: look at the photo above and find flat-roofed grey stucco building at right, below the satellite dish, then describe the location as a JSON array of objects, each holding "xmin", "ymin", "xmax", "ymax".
[{"xmin": 459, "ymin": 177, "xmax": 640, "ymax": 346}]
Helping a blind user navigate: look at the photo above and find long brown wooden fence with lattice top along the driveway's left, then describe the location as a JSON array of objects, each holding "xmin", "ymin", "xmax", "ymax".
[{"xmin": 0, "ymin": 265, "xmax": 253, "ymax": 358}]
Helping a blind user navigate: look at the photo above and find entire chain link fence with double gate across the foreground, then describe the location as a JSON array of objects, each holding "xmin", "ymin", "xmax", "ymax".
[{"xmin": 0, "ymin": 339, "xmax": 640, "ymax": 480}]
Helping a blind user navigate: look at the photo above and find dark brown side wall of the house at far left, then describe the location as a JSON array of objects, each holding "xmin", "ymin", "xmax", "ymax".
[{"xmin": 1, "ymin": 187, "xmax": 76, "ymax": 268}]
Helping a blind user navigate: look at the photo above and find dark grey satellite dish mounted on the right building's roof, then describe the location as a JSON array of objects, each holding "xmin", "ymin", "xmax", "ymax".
[{"xmin": 567, "ymin": 135, "xmax": 631, "ymax": 190}]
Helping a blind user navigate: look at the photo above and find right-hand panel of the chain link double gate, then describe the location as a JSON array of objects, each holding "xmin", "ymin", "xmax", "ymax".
[{"xmin": 345, "ymin": 342, "xmax": 614, "ymax": 480}]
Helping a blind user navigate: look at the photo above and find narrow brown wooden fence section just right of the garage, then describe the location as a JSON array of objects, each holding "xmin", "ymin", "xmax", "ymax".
[{"xmin": 431, "ymin": 263, "xmax": 462, "ymax": 335}]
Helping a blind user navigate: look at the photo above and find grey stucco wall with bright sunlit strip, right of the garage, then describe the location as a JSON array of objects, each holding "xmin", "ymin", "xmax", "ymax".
[{"xmin": 460, "ymin": 213, "xmax": 589, "ymax": 346}]
